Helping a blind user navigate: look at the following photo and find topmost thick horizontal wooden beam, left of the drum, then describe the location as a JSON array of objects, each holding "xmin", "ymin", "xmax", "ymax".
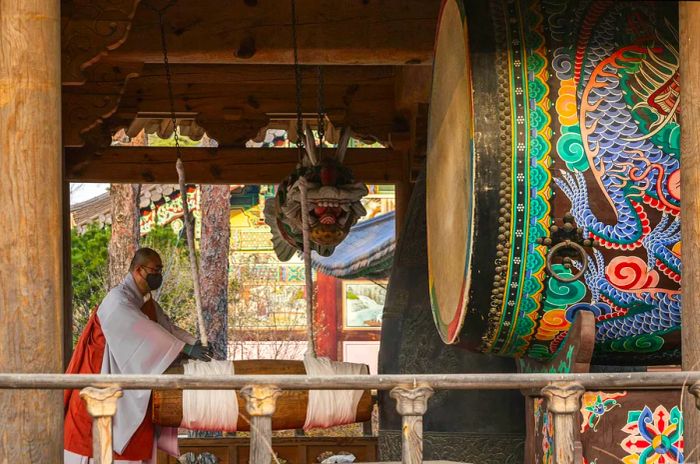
[{"xmin": 87, "ymin": 0, "xmax": 441, "ymax": 65}]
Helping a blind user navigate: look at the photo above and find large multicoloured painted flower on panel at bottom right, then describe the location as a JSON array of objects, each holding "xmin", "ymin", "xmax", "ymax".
[{"xmin": 620, "ymin": 405, "xmax": 683, "ymax": 464}]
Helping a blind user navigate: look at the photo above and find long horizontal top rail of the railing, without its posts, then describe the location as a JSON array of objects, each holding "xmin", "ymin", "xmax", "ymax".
[{"xmin": 0, "ymin": 371, "xmax": 700, "ymax": 390}]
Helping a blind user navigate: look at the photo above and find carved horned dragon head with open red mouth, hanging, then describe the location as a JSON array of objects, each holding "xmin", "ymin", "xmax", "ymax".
[{"xmin": 265, "ymin": 126, "xmax": 368, "ymax": 261}]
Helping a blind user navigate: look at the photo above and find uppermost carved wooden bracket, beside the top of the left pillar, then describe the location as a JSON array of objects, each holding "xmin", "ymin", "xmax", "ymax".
[{"xmin": 61, "ymin": 0, "xmax": 140, "ymax": 85}]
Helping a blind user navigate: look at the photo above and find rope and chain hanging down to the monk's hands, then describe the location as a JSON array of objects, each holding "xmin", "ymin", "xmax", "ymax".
[{"xmin": 147, "ymin": 0, "xmax": 209, "ymax": 346}]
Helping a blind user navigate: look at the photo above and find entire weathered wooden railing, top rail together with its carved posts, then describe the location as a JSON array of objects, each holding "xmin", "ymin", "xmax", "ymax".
[{"xmin": 0, "ymin": 371, "xmax": 700, "ymax": 464}]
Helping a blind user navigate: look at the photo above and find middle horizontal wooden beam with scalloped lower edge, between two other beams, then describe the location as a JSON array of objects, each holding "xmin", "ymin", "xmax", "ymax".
[{"xmin": 63, "ymin": 63, "xmax": 408, "ymax": 147}]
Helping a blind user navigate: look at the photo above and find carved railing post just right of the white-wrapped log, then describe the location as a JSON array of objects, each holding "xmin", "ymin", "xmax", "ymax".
[{"xmin": 391, "ymin": 386, "xmax": 433, "ymax": 464}]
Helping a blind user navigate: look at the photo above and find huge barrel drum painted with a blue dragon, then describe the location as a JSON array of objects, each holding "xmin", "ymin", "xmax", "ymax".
[{"xmin": 426, "ymin": 0, "xmax": 681, "ymax": 364}]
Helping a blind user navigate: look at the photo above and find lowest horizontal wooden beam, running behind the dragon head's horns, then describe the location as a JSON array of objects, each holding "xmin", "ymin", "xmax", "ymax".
[{"xmin": 65, "ymin": 147, "xmax": 406, "ymax": 184}]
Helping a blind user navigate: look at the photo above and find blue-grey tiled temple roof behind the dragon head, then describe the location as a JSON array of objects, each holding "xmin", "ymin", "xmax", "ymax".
[{"xmin": 311, "ymin": 211, "xmax": 396, "ymax": 279}]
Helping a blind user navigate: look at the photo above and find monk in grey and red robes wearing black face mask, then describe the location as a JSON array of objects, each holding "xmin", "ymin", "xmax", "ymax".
[{"xmin": 63, "ymin": 248, "xmax": 211, "ymax": 464}]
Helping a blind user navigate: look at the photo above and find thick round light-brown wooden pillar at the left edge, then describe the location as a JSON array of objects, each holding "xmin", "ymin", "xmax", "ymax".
[{"xmin": 0, "ymin": 0, "xmax": 63, "ymax": 463}]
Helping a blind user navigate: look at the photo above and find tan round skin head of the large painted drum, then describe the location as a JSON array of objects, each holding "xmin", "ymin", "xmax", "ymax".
[{"xmin": 426, "ymin": 0, "xmax": 474, "ymax": 343}]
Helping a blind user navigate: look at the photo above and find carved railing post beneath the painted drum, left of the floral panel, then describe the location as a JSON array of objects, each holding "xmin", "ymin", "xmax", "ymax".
[{"xmin": 542, "ymin": 382, "xmax": 585, "ymax": 464}]
